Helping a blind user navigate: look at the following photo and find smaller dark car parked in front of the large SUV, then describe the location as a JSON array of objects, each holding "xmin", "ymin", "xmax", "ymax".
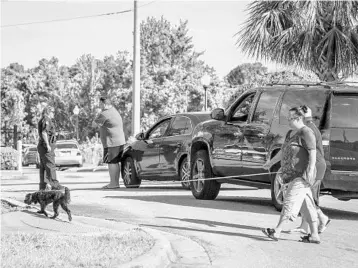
[{"xmin": 121, "ymin": 112, "xmax": 210, "ymax": 189}]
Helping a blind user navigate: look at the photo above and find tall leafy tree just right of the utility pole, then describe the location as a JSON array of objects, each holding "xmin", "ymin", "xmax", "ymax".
[{"xmin": 141, "ymin": 17, "xmax": 217, "ymax": 129}]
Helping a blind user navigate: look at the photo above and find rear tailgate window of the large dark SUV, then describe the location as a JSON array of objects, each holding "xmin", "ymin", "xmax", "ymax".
[{"xmin": 331, "ymin": 95, "xmax": 358, "ymax": 128}]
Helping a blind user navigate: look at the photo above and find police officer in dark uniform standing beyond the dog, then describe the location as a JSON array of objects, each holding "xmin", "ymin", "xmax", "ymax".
[{"xmin": 37, "ymin": 106, "xmax": 63, "ymax": 190}]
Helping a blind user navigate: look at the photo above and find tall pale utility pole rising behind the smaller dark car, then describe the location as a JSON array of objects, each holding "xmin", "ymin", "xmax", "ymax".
[{"xmin": 132, "ymin": 0, "xmax": 140, "ymax": 136}]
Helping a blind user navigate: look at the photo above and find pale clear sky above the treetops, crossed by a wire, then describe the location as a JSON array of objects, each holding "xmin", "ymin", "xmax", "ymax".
[{"xmin": 1, "ymin": 0, "xmax": 276, "ymax": 77}]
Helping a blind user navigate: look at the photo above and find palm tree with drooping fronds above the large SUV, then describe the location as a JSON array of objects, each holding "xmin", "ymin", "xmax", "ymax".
[{"xmin": 237, "ymin": 0, "xmax": 358, "ymax": 81}]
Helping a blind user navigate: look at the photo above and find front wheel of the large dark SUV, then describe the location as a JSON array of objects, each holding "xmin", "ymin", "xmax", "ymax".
[{"xmin": 190, "ymin": 150, "xmax": 221, "ymax": 200}]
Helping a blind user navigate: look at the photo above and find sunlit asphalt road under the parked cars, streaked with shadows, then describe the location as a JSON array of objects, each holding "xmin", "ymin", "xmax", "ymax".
[{"xmin": 1, "ymin": 167, "xmax": 358, "ymax": 268}]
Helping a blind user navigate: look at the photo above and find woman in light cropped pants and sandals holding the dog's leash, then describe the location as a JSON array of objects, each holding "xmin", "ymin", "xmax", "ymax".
[{"xmin": 262, "ymin": 107, "xmax": 320, "ymax": 244}]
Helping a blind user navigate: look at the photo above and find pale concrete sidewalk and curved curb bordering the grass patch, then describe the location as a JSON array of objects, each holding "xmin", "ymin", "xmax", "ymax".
[{"xmin": 1, "ymin": 198, "xmax": 176, "ymax": 268}]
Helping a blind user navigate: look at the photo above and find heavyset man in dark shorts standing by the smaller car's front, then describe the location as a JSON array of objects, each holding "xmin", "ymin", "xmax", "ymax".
[{"xmin": 92, "ymin": 96, "xmax": 126, "ymax": 189}]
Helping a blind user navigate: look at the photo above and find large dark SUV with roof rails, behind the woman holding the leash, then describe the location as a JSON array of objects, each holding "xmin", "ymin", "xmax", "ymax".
[{"xmin": 189, "ymin": 83, "xmax": 358, "ymax": 209}]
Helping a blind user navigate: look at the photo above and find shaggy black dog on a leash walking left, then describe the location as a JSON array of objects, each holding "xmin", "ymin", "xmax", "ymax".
[{"xmin": 24, "ymin": 187, "xmax": 72, "ymax": 221}]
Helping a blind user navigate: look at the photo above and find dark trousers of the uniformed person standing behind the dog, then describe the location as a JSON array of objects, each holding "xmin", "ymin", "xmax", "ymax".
[{"xmin": 37, "ymin": 144, "xmax": 61, "ymax": 190}]
